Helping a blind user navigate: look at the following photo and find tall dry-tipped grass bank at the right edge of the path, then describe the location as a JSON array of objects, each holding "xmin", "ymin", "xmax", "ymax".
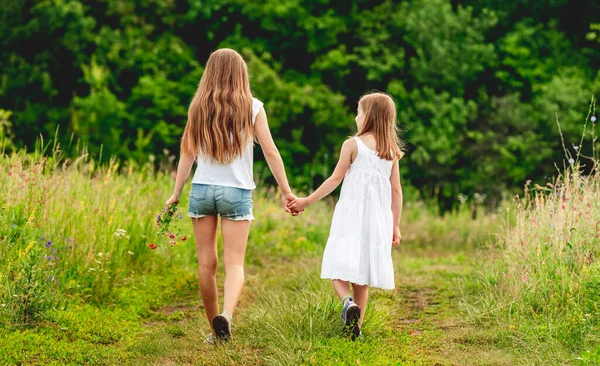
[{"xmin": 463, "ymin": 104, "xmax": 600, "ymax": 363}]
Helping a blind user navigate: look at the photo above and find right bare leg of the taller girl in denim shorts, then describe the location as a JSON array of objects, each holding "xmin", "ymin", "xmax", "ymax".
[{"xmin": 221, "ymin": 219, "xmax": 250, "ymax": 316}]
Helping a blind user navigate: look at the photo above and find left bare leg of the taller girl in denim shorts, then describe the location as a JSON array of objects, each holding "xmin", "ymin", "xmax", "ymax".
[{"xmin": 192, "ymin": 216, "xmax": 219, "ymax": 333}]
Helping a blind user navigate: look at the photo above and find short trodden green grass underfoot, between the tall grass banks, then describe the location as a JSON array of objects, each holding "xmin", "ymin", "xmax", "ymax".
[{"xmin": 0, "ymin": 249, "xmax": 518, "ymax": 365}]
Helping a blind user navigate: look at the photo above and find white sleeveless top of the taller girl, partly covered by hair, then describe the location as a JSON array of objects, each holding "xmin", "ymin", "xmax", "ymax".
[{"xmin": 192, "ymin": 98, "xmax": 263, "ymax": 189}]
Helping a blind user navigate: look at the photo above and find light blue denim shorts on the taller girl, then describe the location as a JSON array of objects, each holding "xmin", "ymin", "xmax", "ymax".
[{"xmin": 188, "ymin": 184, "xmax": 254, "ymax": 221}]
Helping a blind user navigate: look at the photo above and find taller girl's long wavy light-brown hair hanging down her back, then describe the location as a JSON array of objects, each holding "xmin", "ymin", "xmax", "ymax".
[{"xmin": 181, "ymin": 48, "xmax": 254, "ymax": 164}]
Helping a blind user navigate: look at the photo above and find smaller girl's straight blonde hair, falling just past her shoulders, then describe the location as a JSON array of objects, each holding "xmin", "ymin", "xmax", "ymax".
[{"xmin": 358, "ymin": 92, "xmax": 404, "ymax": 160}]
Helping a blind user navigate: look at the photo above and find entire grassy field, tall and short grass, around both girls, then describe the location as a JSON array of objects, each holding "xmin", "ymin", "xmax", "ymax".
[{"xmin": 0, "ymin": 147, "xmax": 600, "ymax": 365}]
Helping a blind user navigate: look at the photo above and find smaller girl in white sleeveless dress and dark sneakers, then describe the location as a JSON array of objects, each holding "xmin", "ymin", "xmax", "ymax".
[{"xmin": 288, "ymin": 93, "xmax": 403, "ymax": 337}]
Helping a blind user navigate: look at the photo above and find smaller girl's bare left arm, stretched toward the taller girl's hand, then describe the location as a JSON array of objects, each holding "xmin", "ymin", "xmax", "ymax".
[{"xmin": 290, "ymin": 139, "xmax": 357, "ymax": 211}]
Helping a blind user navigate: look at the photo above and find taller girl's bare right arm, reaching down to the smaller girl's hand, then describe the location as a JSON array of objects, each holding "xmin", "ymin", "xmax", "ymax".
[{"xmin": 254, "ymin": 108, "xmax": 296, "ymax": 212}]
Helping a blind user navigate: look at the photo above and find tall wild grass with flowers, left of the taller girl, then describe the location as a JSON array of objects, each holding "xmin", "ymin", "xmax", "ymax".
[{"xmin": 0, "ymin": 147, "xmax": 167, "ymax": 322}]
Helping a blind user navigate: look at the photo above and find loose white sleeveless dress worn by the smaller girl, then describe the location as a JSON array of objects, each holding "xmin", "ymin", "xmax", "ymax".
[{"xmin": 321, "ymin": 137, "xmax": 394, "ymax": 290}]
